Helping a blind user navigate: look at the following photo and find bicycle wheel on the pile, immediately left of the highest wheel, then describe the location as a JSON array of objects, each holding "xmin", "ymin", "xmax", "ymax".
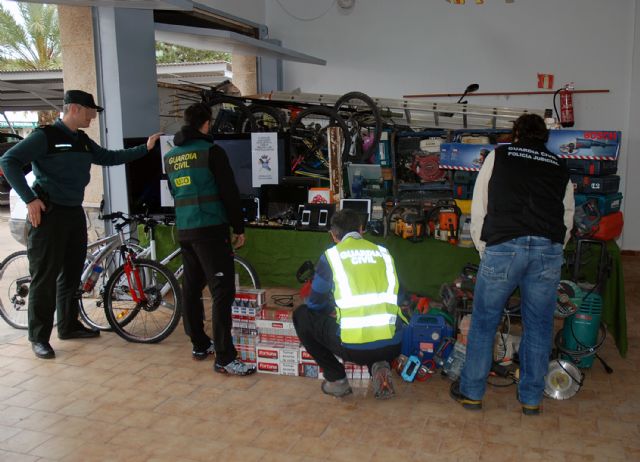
[{"xmin": 289, "ymin": 106, "xmax": 351, "ymax": 176}]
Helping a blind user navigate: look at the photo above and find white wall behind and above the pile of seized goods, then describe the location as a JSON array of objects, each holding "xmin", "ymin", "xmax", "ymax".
[{"xmin": 265, "ymin": 0, "xmax": 640, "ymax": 250}]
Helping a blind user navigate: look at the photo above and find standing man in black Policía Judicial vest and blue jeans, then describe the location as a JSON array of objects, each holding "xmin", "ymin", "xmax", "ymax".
[{"xmin": 451, "ymin": 114, "xmax": 574, "ymax": 415}]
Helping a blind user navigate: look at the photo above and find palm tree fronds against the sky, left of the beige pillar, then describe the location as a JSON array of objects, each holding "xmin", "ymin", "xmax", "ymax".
[{"xmin": 0, "ymin": 3, "xmax": 61, "ymax": 70}]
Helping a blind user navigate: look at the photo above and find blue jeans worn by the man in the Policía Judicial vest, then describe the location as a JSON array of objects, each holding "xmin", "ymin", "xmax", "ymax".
[{"xmin": 460, "ymin": 236, "xmax": 563, "ymax": 405}]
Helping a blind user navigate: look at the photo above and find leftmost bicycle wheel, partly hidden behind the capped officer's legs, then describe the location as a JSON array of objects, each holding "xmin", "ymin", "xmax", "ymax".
[{"xmin": 0, "ymin": 250, "xmax": 31, "ymax": 329}]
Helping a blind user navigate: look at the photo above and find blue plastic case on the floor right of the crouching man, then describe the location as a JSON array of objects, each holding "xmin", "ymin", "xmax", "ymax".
[{"xmin": 401, "ymin": 313, "xmax": 453, "ymax": 363}]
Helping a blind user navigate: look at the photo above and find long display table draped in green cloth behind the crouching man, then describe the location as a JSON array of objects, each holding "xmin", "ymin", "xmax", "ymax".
[{"xmin": 141, "ymin": 226, "xmax": 628, "ymax": 357}]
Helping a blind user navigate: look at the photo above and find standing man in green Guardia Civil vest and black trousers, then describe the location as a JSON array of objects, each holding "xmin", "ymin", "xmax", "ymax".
[{"xmin": 164, "ymin": 103, "xmax": 255, "ymax": 375}]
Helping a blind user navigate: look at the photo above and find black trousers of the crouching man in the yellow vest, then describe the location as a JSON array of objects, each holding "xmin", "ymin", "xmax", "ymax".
[{"xmin": 293, "ymin": 305, "xmax": 401, "ymax": 382}]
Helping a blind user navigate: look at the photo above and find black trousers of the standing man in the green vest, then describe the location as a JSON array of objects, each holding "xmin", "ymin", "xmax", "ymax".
[{"xmin": 180, "ymin": 237, "xmax": 237, "ymax": 366}]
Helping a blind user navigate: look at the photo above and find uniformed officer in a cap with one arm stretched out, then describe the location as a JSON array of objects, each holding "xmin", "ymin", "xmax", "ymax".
[{"xmin": 0, "ymin": 90, "xmax": 160, "ymax": 359}]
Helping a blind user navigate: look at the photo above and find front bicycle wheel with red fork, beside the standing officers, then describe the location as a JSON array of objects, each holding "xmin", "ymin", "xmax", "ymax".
[{"xmin": 105, "ymin": 260, "xmax": 182, "ymax": 343}]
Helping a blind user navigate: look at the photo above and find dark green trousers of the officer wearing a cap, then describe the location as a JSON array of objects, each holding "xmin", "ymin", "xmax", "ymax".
[{"xmin": 27, "ymin": 204, "xmax": 87, "ymax": 342}]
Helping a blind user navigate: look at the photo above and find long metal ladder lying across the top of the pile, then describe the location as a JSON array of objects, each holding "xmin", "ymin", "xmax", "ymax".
[{"xmin": 255, "ymin": 91, "xmax": 544, "ymax": 130}]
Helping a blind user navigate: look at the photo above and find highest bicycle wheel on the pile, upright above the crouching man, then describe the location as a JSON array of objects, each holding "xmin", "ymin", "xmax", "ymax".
[{"xmin": 333, "ymin": 91, "xmax": 382, "ymax": 163}]
